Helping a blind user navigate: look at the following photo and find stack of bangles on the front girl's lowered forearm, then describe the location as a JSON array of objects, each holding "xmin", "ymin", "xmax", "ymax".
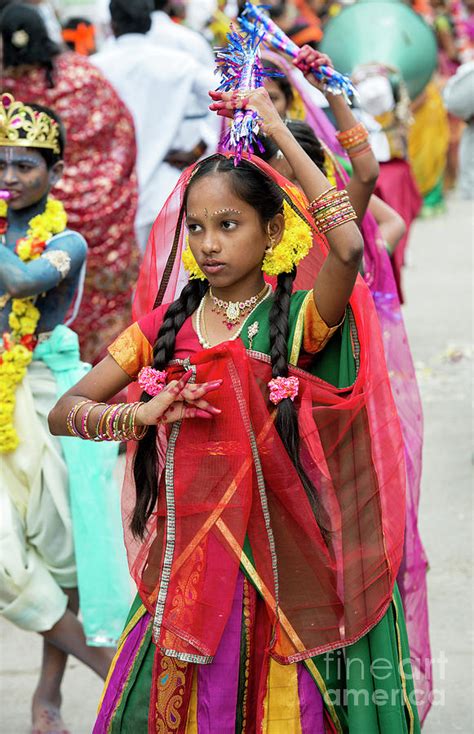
[{"xmin": 66, "ymin": 400, "xmax": 148, "ymax": 441}]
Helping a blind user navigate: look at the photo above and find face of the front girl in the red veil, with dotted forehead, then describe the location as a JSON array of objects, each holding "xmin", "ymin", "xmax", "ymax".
[{"xmin": 186, "ymin": 173, "xmax": 283, "ymax": 288}]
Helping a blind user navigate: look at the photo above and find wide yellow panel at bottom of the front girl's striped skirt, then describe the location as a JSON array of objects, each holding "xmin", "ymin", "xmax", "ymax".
[{"xmin": 262, "ymin": 658, "xmax": 301, "ymax": 734}]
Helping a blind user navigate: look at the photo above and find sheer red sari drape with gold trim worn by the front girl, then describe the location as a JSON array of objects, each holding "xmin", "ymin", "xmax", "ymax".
[{"xmin": 123, "ymin": 158, "xmax": 406, "ymax": 663}]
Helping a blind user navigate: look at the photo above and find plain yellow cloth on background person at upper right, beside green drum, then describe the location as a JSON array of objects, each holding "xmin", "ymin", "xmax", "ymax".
[{"xmin": 408, "ymin": 82, "xmax": 449, "ymax": 196}]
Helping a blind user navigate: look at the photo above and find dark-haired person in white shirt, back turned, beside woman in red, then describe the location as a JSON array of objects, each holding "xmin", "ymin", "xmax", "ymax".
[{"xmin": 90, "ymin": 0, "xmax": 217, "ymax": 252}]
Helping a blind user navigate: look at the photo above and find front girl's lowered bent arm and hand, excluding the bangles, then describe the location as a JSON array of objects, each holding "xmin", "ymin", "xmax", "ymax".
[{"xmin": 48, "ymin": 355, "xmax": 222, "ymax": 436}]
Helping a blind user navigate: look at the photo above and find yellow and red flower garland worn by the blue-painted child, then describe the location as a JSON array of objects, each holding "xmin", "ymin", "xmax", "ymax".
[{"xmin": 0, "ymin": 199, "xmax": 67, "ymax": 453}]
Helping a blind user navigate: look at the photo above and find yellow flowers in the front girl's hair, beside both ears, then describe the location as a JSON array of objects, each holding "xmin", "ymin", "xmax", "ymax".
[{"xmin": 183, "ymin": 199, "xmax": 313, "ymax": 280}]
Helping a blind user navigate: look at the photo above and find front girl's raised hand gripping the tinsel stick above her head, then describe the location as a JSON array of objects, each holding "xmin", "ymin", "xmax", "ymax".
[{"xmin": 209, "ymin": 87, "xmax": 285, "ymax": 136}]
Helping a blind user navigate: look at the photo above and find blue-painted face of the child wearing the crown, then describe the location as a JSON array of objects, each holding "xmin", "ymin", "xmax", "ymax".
[{"xmin": 0, "ymin": 146, "xmax": 53, "ymax": 211}]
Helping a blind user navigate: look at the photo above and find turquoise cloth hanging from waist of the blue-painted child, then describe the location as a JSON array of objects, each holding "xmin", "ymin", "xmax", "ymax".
[{"xmin": 33, "ymin": 324, "xmax": 130, "ymax": 646}]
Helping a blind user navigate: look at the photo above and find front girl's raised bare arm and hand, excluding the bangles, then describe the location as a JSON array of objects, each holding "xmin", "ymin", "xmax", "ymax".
[{"xmin": 211, "ymin": 87, "xmax": 363, "ymax": 326}]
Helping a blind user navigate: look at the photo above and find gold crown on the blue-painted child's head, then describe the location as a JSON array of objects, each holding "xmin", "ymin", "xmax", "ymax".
[{"xmin": 0, "ymin": 93, "xmax": 61, "ymax": 154}]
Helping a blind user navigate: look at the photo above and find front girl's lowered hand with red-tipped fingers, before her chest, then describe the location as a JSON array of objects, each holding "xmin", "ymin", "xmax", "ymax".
[{"xmin": 136, "ymin": 370, "xmax": 222, "ymax": 426}]
